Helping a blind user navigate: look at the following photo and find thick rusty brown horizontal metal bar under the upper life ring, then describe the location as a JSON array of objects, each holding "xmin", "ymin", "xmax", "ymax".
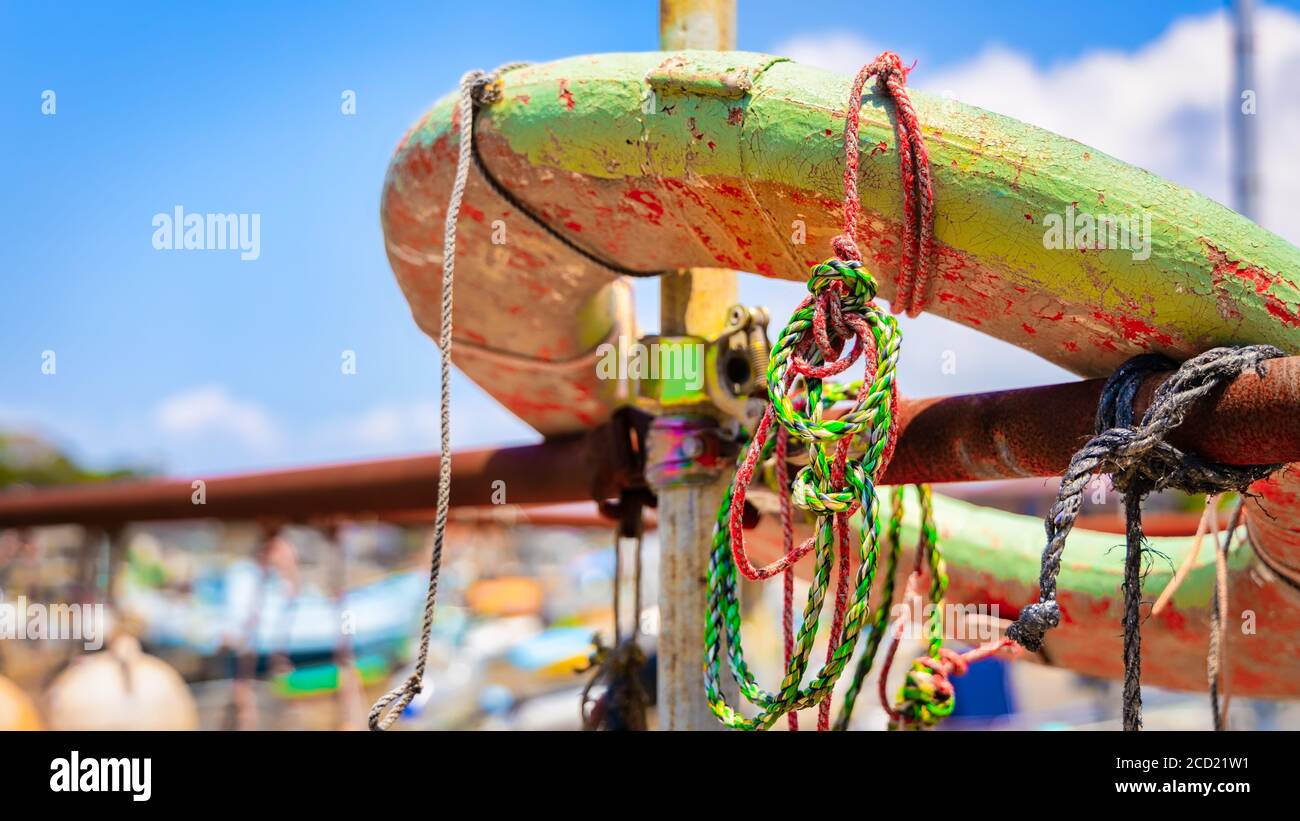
[{"xmin": 0, "ymin": 357, "xmax": 1300, "ymax": 527}]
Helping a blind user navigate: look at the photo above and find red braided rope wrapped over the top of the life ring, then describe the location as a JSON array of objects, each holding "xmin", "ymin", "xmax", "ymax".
[{"xmin": 831, "ymin": 52, "xmax": 935, "ymax": 317}]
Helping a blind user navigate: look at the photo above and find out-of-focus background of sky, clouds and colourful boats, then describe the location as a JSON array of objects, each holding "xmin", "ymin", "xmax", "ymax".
[{"xmin": 0, "ymin": 0, "xmax": 1300, "ymax": 729}]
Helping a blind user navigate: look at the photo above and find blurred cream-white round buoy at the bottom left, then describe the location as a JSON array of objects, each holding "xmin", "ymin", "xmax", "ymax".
[{"xmin": 46, "ymin": 635, "xmax": 199, "ymax": 730}]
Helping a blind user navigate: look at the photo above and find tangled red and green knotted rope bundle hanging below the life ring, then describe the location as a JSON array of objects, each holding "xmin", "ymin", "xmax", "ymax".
[{"xmin": 705, "ymin": 259, "xmax": 900, "ymax": 729}]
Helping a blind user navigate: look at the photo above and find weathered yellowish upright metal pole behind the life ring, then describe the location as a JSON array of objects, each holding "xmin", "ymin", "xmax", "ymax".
[{"xmin": 647, "ymin": 0, "xmax": 736, "ymax": 730}]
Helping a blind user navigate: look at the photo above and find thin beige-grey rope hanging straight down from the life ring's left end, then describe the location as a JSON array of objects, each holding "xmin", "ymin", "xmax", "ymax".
[{"xmin": 368, "ymin": 64, "xmax": 520, "ymax": 730}]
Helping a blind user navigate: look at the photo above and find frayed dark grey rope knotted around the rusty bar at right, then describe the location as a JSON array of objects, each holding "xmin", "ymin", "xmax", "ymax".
[{"xmin": 1006, "ymin": 346, "xmax": 1283, "ymax": 730}]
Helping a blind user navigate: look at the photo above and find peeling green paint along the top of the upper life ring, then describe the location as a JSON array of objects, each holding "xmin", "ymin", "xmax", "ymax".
[{"xmin": 397, "ymin": 52, "xmax": 1300, "ymax": 375}]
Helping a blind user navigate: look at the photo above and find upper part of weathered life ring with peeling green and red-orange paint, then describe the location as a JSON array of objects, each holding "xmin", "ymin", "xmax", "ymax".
[{"xmin": 381, "ymin": 52, "xmax": 1300, "ymax": 434}]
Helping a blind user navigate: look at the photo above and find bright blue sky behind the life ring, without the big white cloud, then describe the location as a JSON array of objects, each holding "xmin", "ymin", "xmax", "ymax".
[{"xmin": 0, "ymin": 0, "xmax": 1300, "ymax": 473}]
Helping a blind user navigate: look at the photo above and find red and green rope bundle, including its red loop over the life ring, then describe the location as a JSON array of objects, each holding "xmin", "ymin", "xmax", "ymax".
[{"xmin": 705, "ymin": 52, "xmax": 951, "ymax": 730}]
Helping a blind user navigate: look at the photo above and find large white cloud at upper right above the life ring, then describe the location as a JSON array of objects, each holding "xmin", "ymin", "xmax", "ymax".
[{"xmin": 774, "ymin": 6, "xmax": 1300, "ymax": 242}]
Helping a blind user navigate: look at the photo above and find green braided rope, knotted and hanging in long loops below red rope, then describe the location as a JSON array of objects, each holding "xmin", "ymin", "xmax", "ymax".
[{"xmin": 705, "ymin": 260, "xmax": 900, "ymax": 730}]
